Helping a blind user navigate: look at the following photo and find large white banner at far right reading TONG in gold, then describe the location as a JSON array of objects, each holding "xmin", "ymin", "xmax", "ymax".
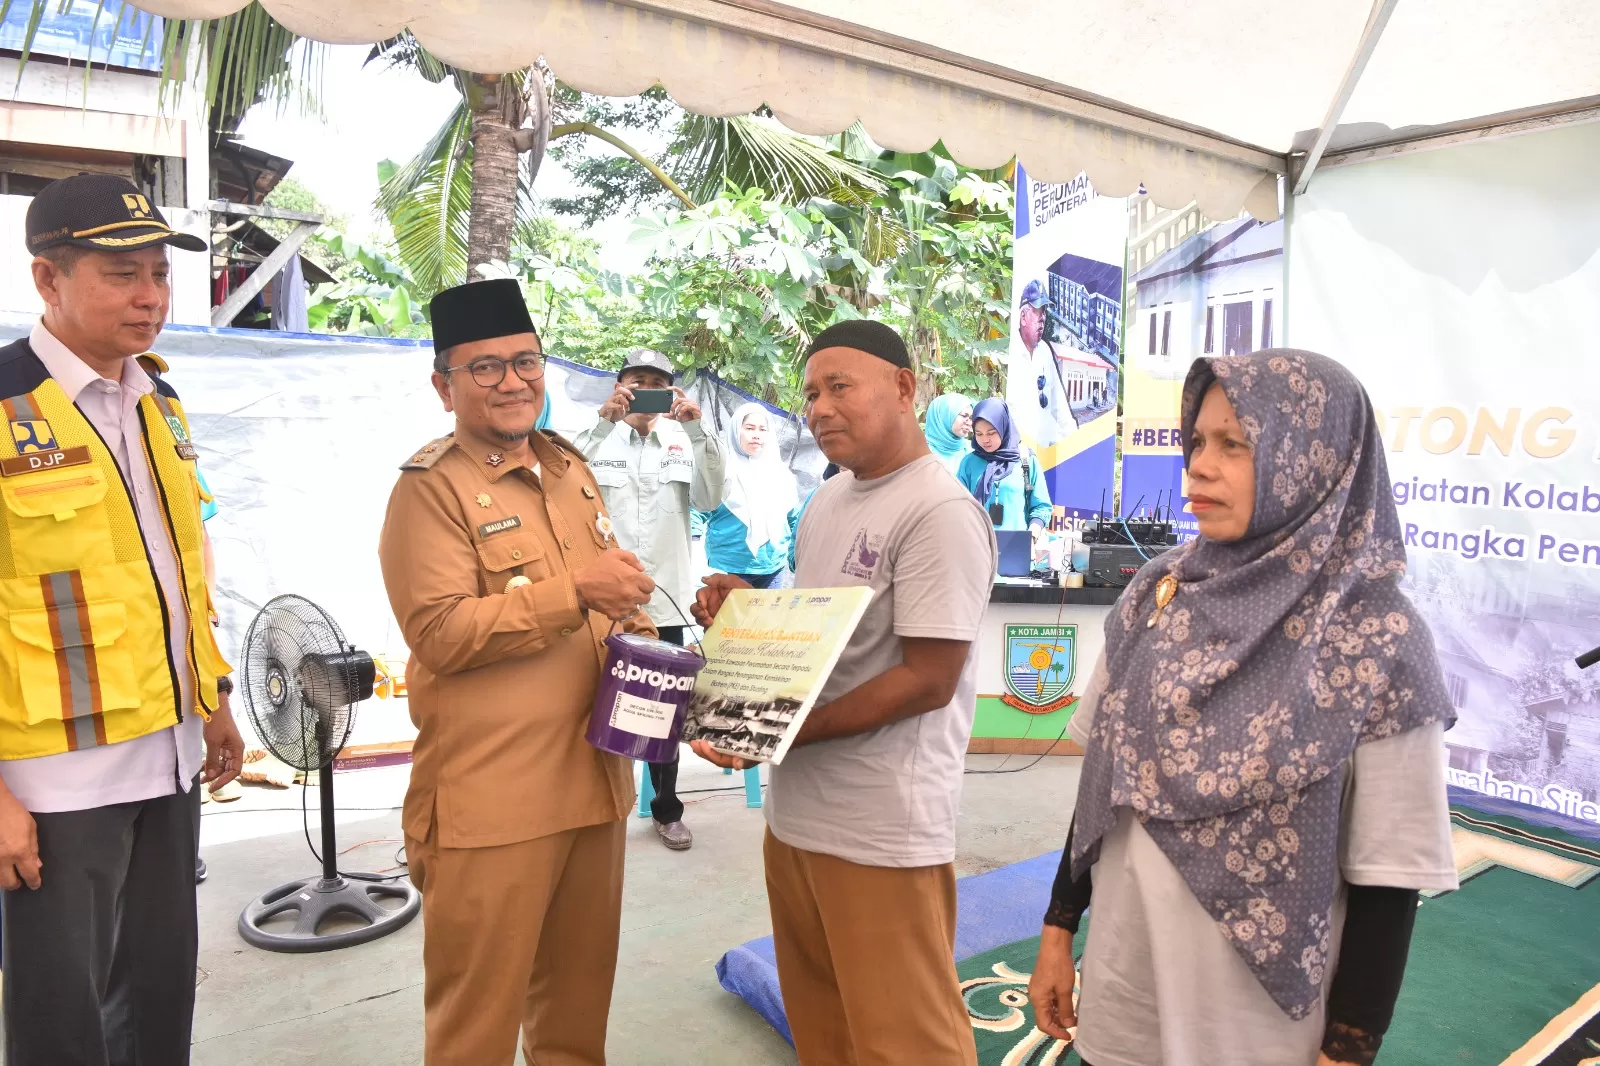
[{"xmin": 1290, "ymin": 125, "xmax": 1600, "ymax": 823}]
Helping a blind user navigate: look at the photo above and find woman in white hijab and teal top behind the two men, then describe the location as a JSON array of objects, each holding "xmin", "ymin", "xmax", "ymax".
[{"xmin": 696, "ymin": 403, "xmax": 800, "ymax": 589}]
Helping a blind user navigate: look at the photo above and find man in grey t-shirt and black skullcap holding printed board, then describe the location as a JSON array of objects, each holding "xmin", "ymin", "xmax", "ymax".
[{"xmin": 694, "ymin": 322, "xmax": 995, "ymax": 1066}]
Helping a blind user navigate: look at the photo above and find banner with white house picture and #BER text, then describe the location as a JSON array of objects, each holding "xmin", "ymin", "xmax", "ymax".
[{"xmin": 1122, "ymin": 192, "xmax": 1283, "ymax": 538}]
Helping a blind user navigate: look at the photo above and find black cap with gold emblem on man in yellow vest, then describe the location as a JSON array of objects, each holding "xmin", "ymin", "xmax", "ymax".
[{"xmin": 27, "ymin": 174, "xmax": 208, "ymax": 256}]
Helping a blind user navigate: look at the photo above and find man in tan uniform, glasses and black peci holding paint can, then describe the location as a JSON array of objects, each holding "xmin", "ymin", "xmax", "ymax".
[{"xmin": 378, "ymin": 280, "xmax": 654, "ymax": 1066}]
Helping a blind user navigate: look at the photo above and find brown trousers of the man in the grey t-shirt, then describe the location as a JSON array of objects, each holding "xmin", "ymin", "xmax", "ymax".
[{"xmin": 763, "ymin": 831, "xmax": 978, "ymax": 1066}]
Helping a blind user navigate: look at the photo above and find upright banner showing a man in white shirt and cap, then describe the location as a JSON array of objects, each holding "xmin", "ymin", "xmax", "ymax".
[{"xmin": 1006, "ymin": 166, "xmax": 1128, "ymax": 519}]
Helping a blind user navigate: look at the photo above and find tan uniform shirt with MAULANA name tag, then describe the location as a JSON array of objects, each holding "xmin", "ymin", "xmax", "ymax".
[{"xmin": 378, "ymin": 434, "xmax": 653, "ymax": 848}]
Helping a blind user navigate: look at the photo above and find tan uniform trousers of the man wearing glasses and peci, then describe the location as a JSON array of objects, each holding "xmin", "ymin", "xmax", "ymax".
[{"xmin": 406, "ymin": 821, "xmax": 627, "ymax": 1066}]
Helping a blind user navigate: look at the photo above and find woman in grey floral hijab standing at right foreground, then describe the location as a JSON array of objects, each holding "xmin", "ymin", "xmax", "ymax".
[{"xmin": 1029, "ymin": 349, "xmax": 1456, "ymax": 1066}]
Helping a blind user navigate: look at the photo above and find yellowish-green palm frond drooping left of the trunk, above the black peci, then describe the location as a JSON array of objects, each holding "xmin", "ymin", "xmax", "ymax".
[{"xmin": 378, "ymin": 101, "xmax": 472, "ymax": 298}]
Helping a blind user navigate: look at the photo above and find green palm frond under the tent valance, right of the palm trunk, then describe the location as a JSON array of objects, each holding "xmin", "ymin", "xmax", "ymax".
[{"xmin": 674, "ymin": 115, "xmax": 886, "ymax": 203}]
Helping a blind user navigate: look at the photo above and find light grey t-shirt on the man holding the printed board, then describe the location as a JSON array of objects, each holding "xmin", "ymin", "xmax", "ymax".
[{"xmin": 765, "ymin": 455, "xmax": 995, "ymax": 866}]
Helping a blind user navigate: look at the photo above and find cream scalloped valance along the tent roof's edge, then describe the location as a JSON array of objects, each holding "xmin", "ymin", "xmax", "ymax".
[{"xmin": 141, "ymin": 0, "xmax": 1282, "ymax": 219}]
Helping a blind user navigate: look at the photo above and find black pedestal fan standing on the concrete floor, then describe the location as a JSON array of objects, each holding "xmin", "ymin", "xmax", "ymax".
[{"xmin": 238, "ymin": 595, "xmax": 422, "ymax": 951}]
